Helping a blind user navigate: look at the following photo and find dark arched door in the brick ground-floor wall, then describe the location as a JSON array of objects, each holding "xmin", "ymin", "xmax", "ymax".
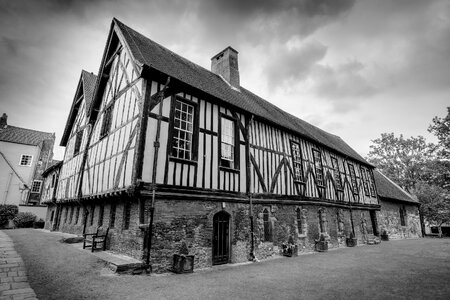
[{"xmin": 212, "ymin": 211, "xmax": 230, "ymax": 265}]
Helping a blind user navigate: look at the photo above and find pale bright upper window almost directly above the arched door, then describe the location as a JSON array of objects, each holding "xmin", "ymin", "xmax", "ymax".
[{"xmin": 220, "ymin": 117, "xmax": 236, "ymax": 168}]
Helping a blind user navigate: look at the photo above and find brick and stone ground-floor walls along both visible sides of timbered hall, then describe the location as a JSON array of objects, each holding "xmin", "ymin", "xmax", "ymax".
[{"xmin": 46, "ymin": 198, "xmax": 398, "ymax": 273}]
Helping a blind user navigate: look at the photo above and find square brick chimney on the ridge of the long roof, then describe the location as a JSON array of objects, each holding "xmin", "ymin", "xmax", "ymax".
[{"xmin": 211, "ymin": 47, "xmax": 240, "ymax": 89}]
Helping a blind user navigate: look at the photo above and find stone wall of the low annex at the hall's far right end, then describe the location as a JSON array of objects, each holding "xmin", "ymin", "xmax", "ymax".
[{"xmin": 378, "ymin": 199, "xmax": 422, "ymax": 239}]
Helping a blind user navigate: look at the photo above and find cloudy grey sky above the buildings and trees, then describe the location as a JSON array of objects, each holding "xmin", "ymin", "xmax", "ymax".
[{"xmin": 0, "ymin": 0, "xmax": 450, "ymax": 159}]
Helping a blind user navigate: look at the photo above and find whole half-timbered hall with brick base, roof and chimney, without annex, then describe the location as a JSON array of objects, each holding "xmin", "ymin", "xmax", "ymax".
[{"xmin": 48, "ymin": 19, "xmax": 386, "ymax": 271}]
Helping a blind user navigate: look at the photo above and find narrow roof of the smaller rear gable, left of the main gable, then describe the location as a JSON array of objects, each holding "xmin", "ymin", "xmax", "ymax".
[{"xmin": 60, "ymin": 70, "xmax": 97, "ymax": 146}]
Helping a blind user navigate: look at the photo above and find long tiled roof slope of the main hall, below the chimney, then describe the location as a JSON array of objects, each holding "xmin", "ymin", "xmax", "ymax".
[{"xmin": 113, "ymin": 19, "xmax": 370, "ymax": 165}]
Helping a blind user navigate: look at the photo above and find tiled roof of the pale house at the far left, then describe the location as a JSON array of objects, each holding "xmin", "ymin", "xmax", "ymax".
[{"xmin": 0, "ymin": 125, "xmax": 54, "ymax": 146}]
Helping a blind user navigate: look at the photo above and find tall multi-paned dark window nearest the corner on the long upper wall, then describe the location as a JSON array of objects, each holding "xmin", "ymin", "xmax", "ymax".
[{"xmin": 172, "ymin": 100, "xmax": 194, "ymax": 160}]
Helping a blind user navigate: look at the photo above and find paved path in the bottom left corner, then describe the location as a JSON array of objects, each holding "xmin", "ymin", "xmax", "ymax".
[{"xmin": 0, "ymin": 230, "xmax": 37, "ymax": 300}]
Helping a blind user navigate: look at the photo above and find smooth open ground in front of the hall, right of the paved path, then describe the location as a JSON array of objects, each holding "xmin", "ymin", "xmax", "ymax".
[{"xmin": 6, "ymin": 229, "xmax": 450, "ymax": 299}]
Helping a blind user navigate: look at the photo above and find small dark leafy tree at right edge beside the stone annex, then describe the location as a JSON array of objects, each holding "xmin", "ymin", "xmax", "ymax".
[{"xmin": 413, "ymin": 182, "xmax": 450, "ymax": 237}]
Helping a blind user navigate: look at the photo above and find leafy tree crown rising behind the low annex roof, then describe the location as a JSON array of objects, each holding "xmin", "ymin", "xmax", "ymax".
[{"xmin": 367, "ymin": 133, "xmax": 436, "ymax": 191}]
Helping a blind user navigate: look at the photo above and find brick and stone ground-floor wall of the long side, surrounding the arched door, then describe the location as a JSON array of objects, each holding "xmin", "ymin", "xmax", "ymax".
[{"xmin": 147, "ymin": 200, "xmax": 373, "ymax": 272}]
